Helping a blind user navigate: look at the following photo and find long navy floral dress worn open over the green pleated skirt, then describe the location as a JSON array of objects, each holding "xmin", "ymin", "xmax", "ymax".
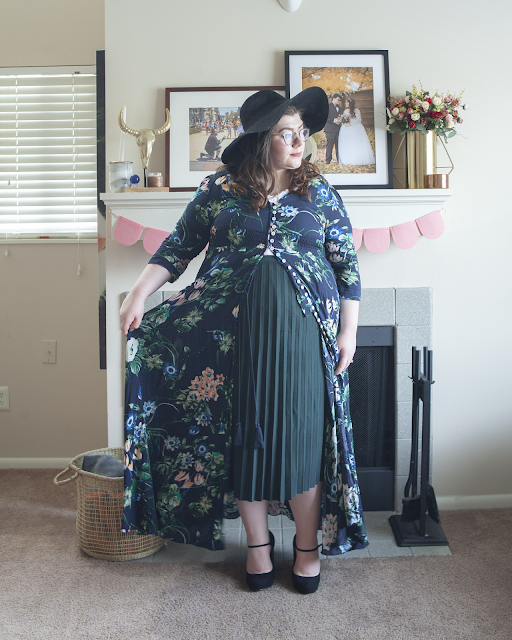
[{"xmin": 124, "ymin": 172, "xmax": 368, "ymax": 555}]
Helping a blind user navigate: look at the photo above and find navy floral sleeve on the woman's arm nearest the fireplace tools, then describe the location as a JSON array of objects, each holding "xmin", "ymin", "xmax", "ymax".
[{"xmin": 324, "ymin": 187, "xmax": 361, "ymax": 300}]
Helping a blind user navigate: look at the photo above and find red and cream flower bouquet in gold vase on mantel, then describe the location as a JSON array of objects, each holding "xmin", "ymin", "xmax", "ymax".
[{"xmin": 386, "ymin": 85, "xmax": 469, "ymax": 189}]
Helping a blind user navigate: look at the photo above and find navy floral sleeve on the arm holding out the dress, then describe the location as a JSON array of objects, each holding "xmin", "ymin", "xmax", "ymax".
[{"xmin": 149, "ymin": 176, "xmax": 214, "ymax": 282}]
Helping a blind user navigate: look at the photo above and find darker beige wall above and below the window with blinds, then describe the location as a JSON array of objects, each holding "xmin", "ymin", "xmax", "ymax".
[{"xmin": 0, "ymin": 0, "xmax": 107, "ymax": 466}]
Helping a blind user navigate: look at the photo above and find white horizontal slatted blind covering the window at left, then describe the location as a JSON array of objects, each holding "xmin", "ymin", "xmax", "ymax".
[{"xmin": 0, "ymin": 67, "xmax": 97, "ymax": 241}]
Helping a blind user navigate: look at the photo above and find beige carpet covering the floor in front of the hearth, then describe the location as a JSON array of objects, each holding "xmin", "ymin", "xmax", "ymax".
[{"xmin": 0, "ymin": 470, "xmax": 512, "ymax": 640}]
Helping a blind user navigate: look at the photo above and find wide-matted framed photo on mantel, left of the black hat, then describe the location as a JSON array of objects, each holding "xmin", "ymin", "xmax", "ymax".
[{"xmin": 165, "ymin": 87, "xmax": 285, "ymax": 191}]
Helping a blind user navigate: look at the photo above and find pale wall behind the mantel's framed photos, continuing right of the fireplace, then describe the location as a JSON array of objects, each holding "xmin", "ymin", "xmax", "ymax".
[{"xmin": 105, "ymin": 0, "xmax": 512, "ymax": 506}]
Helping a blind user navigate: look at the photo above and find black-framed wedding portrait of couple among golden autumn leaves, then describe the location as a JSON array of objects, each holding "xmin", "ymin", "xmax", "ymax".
[{"xmin": 285, "ymin": 51, "xmax": 393, "ymax": 189}]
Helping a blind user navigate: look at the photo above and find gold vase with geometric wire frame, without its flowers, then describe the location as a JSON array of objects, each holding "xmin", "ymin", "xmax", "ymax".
[{"xmin": 393, "ymin": 131, "xmax": 453, "ymax": 189}]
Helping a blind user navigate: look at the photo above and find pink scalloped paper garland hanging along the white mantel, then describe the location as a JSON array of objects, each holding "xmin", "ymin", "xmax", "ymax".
[{"xmin": 112, "ymin": 210, "xmax": 445, "ymax": 255}]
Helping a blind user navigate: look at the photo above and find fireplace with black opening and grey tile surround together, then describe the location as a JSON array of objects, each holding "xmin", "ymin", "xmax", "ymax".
[{"xmin": 356, "ymin": 287, "xmax": 432, "ymax": 511}]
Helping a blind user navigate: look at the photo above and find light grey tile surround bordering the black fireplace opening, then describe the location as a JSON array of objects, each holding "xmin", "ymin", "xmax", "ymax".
[{"xmin": 140, "ymin": 287, "xmax": 435, "ymax": 511}]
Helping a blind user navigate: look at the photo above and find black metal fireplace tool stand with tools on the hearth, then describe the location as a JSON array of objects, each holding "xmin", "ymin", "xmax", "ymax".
[{"xmin": 389, "ymin": 347, "xmax": 448, "ymax": 547}]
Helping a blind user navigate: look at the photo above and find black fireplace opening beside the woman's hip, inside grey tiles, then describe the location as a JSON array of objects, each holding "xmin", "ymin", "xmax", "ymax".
[{"xmin": 349, "ymin": 327, "xmax": 395, "ymax": 511}]
